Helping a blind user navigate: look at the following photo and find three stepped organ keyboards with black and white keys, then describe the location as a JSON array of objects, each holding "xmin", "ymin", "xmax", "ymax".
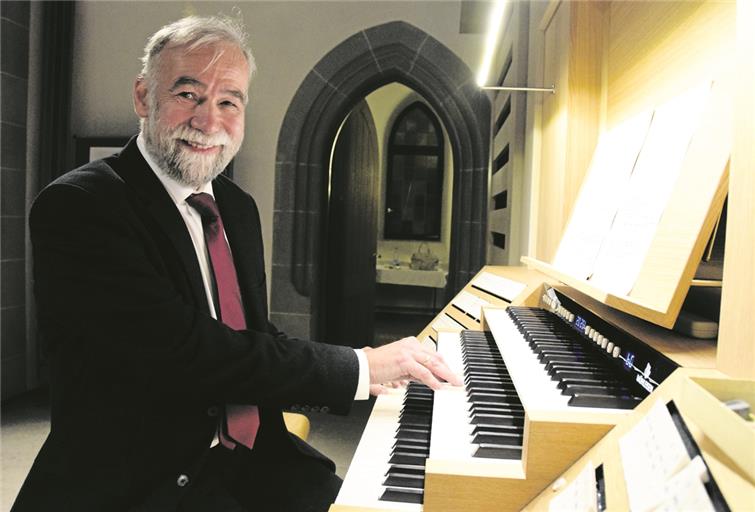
[{"xmin": 331, "ymin": 270, "xmax": 677, "ymax": 512}]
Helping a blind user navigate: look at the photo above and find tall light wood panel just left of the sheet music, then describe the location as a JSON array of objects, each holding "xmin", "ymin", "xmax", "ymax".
[{"xmin": 536, "ymin": 2, "xmax": 608, "ymax": 260}]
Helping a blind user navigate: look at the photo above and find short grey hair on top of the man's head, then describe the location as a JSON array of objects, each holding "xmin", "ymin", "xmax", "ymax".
[{"xmin": 141, "ymin": 15, "xmax": 256, "ymax": 83}]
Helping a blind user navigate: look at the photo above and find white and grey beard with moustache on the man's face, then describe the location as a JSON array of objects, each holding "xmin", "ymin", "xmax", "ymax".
[{"xmin": 142, "ymin": 108, "xmax": 244, "ymax": 189}]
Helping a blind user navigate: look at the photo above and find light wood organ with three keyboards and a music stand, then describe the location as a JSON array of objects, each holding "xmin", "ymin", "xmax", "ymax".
[{"xmin": 331, "ymin": 2, "xmax": 755, "ymax": 512}]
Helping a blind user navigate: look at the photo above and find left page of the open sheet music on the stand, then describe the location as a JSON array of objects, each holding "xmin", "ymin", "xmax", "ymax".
[{"xmin": 553, "ymin": 111, "xmax": 652, "ymax": 279}]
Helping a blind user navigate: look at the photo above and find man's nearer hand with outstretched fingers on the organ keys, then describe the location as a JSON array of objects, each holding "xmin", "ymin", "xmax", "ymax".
[{"xmin": 364, "ymin": 336, "xmax": 462, "ymax": 395}]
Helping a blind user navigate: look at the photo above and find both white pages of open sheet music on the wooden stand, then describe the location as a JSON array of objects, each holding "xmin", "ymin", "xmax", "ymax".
[{"xmin": 553, "ymin": 74, "xmax": 732, "ymax": 295}]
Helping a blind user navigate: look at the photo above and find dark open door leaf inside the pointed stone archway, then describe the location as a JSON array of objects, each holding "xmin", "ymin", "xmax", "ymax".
[{"xmin": 321, "ymin": 100, "xmax": 380, "ymax": 347}]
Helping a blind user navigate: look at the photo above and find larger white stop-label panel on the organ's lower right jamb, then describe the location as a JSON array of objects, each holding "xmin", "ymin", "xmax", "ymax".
[{"xmin": 619, "ymin": 400, "xmax": 690, "ymax": 511}]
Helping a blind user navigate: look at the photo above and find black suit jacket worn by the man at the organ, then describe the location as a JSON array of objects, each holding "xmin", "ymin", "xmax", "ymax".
[{"xmin": 15, "ymin": 139, "xmax": 358, "ymax": 511}]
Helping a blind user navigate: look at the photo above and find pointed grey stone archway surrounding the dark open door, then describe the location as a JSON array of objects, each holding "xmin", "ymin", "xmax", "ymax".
[{"xmin": 270, "ymin": 21, "xmax": 490, "ymax": 337}]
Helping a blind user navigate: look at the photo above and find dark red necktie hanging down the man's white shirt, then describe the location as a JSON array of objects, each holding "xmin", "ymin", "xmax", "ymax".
[{"xmin": 186, "ymin": 192, "xmax": 260, "ymax": 449}]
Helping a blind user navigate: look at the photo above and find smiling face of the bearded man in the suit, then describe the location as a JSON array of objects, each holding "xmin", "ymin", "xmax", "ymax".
[{"xmin": 134, "ymin": 43, "xmax": 249, "ymax": 188}]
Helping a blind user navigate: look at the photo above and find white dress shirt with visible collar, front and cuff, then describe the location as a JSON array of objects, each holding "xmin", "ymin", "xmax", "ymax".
[{"xmin": 136, "ymin": 133, "xmax": 370, "ymax": 400}]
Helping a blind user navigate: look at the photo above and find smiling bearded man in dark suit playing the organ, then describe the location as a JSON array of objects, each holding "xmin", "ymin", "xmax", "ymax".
[{"xmin": 14, "ymin": 17, "xmax": 460, "ymax": 512}]
